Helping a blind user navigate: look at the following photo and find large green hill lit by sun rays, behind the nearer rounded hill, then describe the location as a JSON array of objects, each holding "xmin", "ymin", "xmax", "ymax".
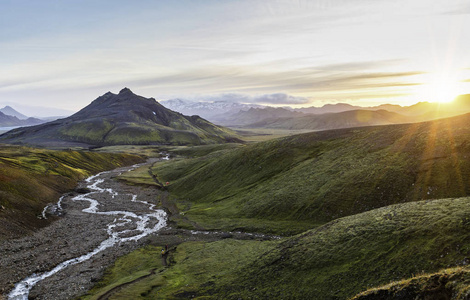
[{"xmin": 152, "ymin": 114, "xmax": 470, "ymax": 234}]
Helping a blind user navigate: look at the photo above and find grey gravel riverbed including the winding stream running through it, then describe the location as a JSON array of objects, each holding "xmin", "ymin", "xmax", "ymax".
[{"xmin": 0, "ymin": 166, "xmax": 166, "ymax": 300}]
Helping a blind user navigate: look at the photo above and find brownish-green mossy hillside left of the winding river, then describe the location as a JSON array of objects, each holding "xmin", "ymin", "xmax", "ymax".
[{"xmin": 0, "ymin": 145, "xmax": 143, "ymax": 239}]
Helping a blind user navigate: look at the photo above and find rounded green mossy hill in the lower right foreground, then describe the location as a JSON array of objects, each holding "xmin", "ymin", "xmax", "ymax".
[{"xmin": 218, "ymin": 198, "xmax": 470, "ymax": 300}]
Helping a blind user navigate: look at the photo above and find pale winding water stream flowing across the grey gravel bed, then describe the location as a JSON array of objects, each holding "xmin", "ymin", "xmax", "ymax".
[{"xmin": 8, "ymin": 165, "xmax": 166, "ymax": 300}]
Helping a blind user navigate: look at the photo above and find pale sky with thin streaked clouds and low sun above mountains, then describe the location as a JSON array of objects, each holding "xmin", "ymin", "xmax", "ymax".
[{"xmin": 0, "ymin": 0, "xmax": 470, "ymax": 115}]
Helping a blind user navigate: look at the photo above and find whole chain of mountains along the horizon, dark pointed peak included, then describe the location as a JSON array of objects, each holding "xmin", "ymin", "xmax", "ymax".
[{"xmin": 4, "ymin": 89, "xmax": 470, "ymax": 142}]
